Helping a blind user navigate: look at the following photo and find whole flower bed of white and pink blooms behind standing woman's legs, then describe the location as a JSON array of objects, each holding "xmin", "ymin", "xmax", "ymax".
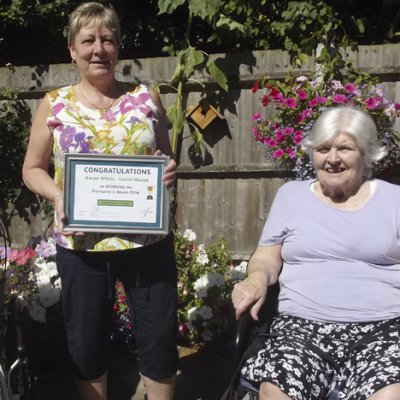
[{"xmin": 0, "ymin": 229, "xmax": 246, "ymax": 345}]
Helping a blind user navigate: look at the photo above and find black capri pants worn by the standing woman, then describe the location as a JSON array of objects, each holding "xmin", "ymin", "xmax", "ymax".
[{"xmin": 56, "ymin": 234, "xmax": 178, "ymax": 380}]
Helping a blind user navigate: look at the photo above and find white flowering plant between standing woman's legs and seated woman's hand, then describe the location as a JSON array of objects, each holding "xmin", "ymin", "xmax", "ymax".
[{"xmin": 175, "ymin": 229, "xmax": 247, "ymax": 345}]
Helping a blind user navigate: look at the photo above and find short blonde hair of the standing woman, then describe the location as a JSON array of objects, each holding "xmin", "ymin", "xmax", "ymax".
[{"xmin": 67, "ymin": 1, "xmax": 121, "ymax": 46}]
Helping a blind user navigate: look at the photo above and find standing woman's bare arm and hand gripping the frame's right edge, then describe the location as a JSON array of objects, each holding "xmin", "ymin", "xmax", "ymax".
[{"xmin": 150, "ymin": 89, "xmax": 176, "ymax": 186}]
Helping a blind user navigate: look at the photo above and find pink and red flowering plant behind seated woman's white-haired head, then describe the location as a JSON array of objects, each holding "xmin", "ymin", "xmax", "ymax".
[{"xmin": 252, "ymin": 74, "xmax": 400, "ymax": 179}]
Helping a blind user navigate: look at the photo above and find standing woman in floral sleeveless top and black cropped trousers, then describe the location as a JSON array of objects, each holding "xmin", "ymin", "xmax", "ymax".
[{"xmin": 23, "ymin": 2, "xmax": 178, "ymax": 400}]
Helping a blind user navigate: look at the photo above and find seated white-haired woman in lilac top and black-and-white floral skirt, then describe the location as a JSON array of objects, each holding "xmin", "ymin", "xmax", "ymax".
[{"xmin": 232, "ymin": 107, "xmax": 400, "ymax": 400}]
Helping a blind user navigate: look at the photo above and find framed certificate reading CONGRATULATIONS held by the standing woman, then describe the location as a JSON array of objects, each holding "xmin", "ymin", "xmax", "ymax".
[{"xmin": 64, "ymin": 153, "xmax": 169, "ymax": 234}]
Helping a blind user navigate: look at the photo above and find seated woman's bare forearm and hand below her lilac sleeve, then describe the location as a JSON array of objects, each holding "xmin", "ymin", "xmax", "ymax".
[{"xmin": 232, "ymin": 245, "xmax": 282, "ymax": 320}]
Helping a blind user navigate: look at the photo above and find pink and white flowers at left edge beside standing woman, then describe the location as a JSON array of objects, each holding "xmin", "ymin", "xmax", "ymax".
[{"xmin": 0, "ymin": 238, "xmax": 61, "ymax": 323}]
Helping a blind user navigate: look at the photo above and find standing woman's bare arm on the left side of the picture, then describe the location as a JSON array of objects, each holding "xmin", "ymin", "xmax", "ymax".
[{"xmin": 22, "ymin": 96, "xmax": 64, "ymax": 230}]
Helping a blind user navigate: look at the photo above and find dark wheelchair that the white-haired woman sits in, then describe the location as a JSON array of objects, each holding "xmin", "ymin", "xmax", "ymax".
[{"xmin": 220, "ymin": 283, "xmax": 339, "ymax": 400}]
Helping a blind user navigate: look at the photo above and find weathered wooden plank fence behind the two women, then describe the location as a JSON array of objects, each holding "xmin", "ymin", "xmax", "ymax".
[{"xmin": 0, "ymin": 44, "xmax": 400, "ymax": 259}]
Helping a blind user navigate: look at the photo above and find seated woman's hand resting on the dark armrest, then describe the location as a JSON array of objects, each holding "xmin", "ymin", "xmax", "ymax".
[{"xmin": 232, "ymin": 273, "xmax": 267, "ymax": 320}]
